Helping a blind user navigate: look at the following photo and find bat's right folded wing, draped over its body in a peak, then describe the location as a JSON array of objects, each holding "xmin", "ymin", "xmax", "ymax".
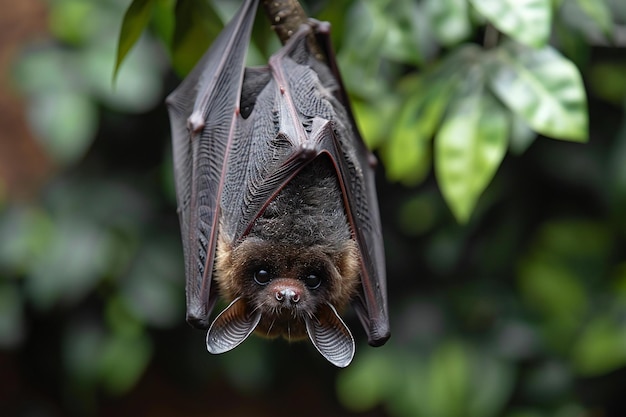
[{"xmin": 217, "ymin": 24, "xmax": 389, "ymax": 348}]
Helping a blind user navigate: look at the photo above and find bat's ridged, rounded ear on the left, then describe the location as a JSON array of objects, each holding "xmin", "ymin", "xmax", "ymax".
[{"xmin": 206, "ymin": 297, "xmax": 261, "ymax": 354}]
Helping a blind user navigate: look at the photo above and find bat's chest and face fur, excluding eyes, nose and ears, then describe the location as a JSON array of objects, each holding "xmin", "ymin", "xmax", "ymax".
[{"xmin": 215, "ymin": 158, "xmax": 359, "ymax": 340}]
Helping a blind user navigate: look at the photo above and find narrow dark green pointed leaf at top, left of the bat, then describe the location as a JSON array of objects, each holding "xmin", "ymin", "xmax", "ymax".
[{"xmin": 113, "ymin": 0, "xmax": 153, "ymax": 80}]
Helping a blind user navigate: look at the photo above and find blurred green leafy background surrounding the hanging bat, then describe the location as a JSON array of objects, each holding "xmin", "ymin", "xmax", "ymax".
[{"xmin": 0, "ymin": 0, "xmax": 626, "ymax": 417}]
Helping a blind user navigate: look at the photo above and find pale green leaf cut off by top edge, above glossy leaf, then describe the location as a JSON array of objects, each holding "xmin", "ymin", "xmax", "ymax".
[{"xmin": 470, "ymin": 0, "xmax": 552, "ymax": 47}]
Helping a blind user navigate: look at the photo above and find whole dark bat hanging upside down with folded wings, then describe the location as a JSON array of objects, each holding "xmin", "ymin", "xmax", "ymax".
[{"xmin": 166, "ymin": 0, "xmax": 390, "ymax": 367}]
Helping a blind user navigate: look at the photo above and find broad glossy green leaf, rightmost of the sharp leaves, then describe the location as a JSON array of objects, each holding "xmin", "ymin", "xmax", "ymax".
[{"xmin": 489, "ymin": 42, "xmax": 588, "ymax": 142}]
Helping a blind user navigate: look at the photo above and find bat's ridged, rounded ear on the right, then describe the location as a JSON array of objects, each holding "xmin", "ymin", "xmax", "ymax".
[{"xmin": 306, "ymin": 304, "xmax": 354, "ymax": 368}]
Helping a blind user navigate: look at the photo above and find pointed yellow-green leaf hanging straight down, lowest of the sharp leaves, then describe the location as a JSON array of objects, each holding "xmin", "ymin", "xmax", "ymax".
[{"xmin": 435, "ymin": 62, "xmax": 509, "ymax": 222}]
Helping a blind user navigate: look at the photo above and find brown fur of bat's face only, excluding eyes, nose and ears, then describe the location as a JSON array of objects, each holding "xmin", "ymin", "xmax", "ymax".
[{"xmin": 215, "ymin": 232, "xmax": 360, "ymax": 340}]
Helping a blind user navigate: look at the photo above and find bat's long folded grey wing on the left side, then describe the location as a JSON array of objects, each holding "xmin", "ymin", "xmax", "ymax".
[{"xmin": 167, "ymin": 0, "xmax": 258, "ymax": 328}]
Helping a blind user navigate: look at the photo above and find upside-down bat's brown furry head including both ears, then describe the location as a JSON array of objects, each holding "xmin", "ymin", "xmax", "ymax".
[{"xmin": 207, "ymin": 234, "xmax": 360, "ymax": 366}]
